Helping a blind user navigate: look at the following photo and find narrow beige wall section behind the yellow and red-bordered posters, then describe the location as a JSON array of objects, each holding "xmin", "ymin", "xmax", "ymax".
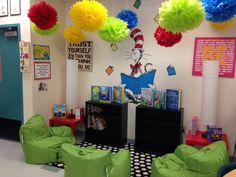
[{"xmin": 31, "ymin": 0, "xmax": 66, "ymax": 123}]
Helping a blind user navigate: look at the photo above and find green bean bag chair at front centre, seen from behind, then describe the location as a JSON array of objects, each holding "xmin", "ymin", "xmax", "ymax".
[{"xmin": 62, "ymin": 144, "xmax": 131, "ymax": 177}]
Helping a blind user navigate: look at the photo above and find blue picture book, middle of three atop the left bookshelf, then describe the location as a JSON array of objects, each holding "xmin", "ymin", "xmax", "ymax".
[{"xmin": 99, "ymin": 86, "xmax": 112, "ymax": 103}]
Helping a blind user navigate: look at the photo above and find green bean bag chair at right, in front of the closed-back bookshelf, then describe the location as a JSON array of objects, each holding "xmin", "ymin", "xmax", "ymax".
[{"xmin": 151, "ymin": 141, "xmax": 229, "ymax": 177}]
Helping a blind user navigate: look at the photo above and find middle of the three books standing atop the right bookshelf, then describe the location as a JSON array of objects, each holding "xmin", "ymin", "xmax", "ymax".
[{"xmin": 153, "ymin": 89, "xmax": 166, "ymax": 109}]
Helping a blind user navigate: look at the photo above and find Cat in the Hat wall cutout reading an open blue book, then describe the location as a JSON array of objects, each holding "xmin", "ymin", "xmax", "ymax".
[{"xmin": 121, "ymin": 28, "xmax": 156, "ymax": 104}]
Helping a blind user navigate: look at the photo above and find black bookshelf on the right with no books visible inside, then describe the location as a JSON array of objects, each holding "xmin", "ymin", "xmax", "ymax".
[{"xmin": 135, "ymin": 105, "xmax": 184, "ymax": 155}]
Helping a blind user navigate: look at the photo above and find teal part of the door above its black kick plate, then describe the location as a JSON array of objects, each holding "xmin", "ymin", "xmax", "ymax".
[{"xmin": 0, "ymin": 24, "xmax": 23, "ymax": 122}]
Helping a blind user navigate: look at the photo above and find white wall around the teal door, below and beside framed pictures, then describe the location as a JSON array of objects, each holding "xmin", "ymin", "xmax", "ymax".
[{"xmin": 0, "ymin": 0, "xmax": 33, "ymax": 119}]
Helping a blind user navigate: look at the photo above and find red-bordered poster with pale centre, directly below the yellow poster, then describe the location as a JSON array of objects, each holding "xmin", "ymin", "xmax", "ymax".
[{"xmin": 34, "ymin": 62, "xmax": 51, "ymax": 80}]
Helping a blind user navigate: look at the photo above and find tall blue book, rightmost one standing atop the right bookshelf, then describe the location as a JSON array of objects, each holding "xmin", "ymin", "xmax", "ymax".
[{"xmin": 166, "ymin": 89, "xmax": 181, "ymax": 111}]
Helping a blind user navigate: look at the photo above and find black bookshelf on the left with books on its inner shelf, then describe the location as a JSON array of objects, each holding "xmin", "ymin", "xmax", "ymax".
[{"xmin": 85, "ymin": 101, "xmax": 128, "ymax": 146}]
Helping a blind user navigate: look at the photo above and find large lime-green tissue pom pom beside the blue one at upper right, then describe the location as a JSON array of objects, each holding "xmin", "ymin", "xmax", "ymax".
[{"xmin": 159, "ymin": 0, "xmax": 205, "ymax": 33}]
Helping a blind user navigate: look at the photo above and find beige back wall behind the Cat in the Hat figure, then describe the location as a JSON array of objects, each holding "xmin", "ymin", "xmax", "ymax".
[{"xmin": 66, "ymin": 0, "xmax": 236, "ymax": 153}]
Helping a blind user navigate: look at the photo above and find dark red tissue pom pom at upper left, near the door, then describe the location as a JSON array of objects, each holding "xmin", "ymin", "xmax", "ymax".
[{"xmin": 28, "ymin": 1, "xmax": 57, "ymax": 30}]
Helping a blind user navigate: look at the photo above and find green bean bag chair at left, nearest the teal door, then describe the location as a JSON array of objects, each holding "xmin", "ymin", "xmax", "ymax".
[{"xmin": 19, "ymin": 114, "xmax": 75, "ymax": 164}]
